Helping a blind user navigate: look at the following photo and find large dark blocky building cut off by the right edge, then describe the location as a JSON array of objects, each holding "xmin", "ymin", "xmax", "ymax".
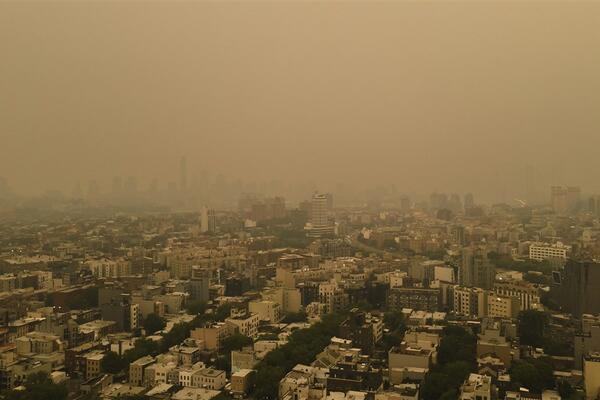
[{"xmin": 558, "ymin": 260, "xmax": 600, "ymax": 318}]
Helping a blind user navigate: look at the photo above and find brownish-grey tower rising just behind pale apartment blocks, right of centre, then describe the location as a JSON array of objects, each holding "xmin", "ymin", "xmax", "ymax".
[{"xmin": 460, "ymin": 246, "xmax": 496, "ymax": 289}]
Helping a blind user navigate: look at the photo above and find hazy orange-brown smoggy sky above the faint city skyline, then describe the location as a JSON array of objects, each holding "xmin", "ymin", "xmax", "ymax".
[{"xmin": 0, "ymin": 1, "xmax": 600, "ymax": 197}]
